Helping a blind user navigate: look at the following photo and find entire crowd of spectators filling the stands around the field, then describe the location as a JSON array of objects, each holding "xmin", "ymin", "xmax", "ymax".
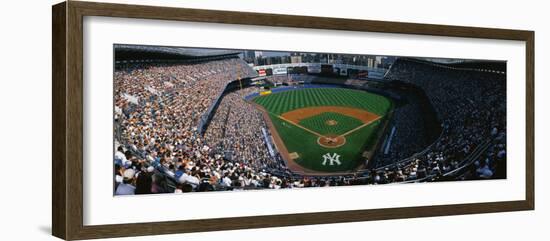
[{"xmin": 114, "ymin": 55, "xmax": 506, "ymax": 195}]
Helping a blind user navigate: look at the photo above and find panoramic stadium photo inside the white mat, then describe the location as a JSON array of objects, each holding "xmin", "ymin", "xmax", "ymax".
[{"xmin": 113, "ymin": 44, "xmax": 506, "ymax": 195}]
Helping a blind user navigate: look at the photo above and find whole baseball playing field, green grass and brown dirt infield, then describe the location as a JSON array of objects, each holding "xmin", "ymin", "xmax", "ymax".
[{"xmin": 253, "ymin": 88, "xmax": 392, "ymax": 174}]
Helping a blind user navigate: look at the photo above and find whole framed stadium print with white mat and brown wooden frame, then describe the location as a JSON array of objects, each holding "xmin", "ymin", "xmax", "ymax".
[{"xmin": 52, "ymin": 1, "xmax": 534, "ymax": 240}]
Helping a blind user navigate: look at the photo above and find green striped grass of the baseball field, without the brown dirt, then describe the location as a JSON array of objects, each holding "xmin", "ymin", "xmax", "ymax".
[{"xmin": 253, "ymin": 88, "xmax": 392, "ymax": 172}]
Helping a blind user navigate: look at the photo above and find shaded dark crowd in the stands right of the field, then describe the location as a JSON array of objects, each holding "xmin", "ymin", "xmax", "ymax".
[{"xmin": 382, "ymin": 59, "xmax": 506, "ymax": 180}]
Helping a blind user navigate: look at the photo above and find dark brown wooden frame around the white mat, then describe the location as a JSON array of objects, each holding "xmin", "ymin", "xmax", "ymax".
[{"xmin": 52, "ymin": 1, "xmax": 535, "ymax": 240}]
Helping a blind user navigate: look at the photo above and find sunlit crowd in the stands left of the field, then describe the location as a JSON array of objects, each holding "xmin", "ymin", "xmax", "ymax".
[{"xmin": 114, "ymin": 58, "xmax": 276, "ymax": 194}]
